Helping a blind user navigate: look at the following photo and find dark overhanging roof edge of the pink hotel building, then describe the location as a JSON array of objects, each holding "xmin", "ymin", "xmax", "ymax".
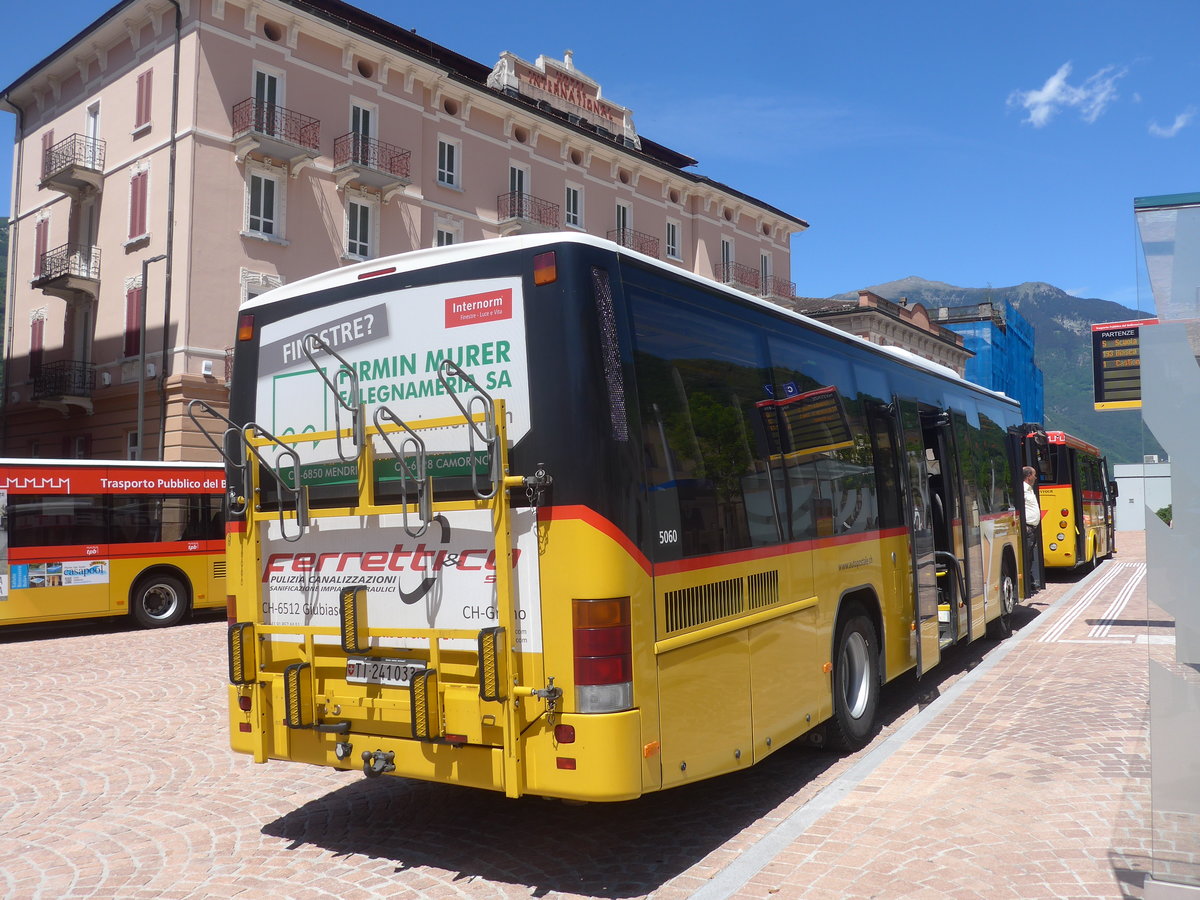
[{"xmin": 0, "ymin": 0, "xmax": 809, "ymax": 229}]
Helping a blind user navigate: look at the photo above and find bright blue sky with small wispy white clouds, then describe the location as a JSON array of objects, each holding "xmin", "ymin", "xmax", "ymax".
[{"xmin": 0, "ymin": 0, "xmax": 1200, "ymax": 308}]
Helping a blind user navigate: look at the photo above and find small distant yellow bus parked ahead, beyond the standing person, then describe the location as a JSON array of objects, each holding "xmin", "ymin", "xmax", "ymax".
[{"xmin": 1025, "ymin": 427, "xmax": 1117, "ymax": 569}]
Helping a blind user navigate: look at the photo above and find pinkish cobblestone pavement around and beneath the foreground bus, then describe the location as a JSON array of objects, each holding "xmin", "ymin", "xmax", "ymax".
[{"xmin": 0, "ymin": 534, "xmax": 1148, "ymax": 900}]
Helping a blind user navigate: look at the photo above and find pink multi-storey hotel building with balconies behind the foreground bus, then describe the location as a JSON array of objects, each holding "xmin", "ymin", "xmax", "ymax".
[{"xmin": 0, "ymin": 0, "xmax": 806, "ymax": 460}]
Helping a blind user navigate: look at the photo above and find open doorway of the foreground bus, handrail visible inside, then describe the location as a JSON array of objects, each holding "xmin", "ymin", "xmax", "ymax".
[{"xmin": 920, "ymin": 408, "xmax": 979, "ymax": 647}]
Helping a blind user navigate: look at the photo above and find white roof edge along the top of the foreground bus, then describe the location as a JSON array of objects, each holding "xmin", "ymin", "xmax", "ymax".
[{"xmin": 240, "ymin": 232, "xmax": 1016, "ymax": 404}]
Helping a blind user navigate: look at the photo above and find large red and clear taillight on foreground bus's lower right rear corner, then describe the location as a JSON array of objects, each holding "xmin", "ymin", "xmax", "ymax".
[{"xmin": 571, "ymin": 596, "xmax": 634, "ymax": 713}]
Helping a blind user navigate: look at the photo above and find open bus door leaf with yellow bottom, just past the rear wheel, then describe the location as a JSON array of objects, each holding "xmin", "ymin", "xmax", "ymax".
[{"xmin": 893, "ymin": 398, "xmax": 941, "ymax": 674}]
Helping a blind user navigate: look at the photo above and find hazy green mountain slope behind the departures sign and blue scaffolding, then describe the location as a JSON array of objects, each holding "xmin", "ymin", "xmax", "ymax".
[{"xmin": 834, "ymin": 276, "xmax": 1163, "ymax": 466}]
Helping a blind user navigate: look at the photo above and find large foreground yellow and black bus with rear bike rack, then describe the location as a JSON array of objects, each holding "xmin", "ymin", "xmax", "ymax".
[{"xmin": 206, "ymin": 234, "xmax": 1022, "ymax": 800}]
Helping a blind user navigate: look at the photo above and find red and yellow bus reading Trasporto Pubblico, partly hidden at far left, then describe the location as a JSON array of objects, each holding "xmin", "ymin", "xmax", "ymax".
[{"xmin": 0, "ymin": 460, "xmax": 226, "ymax": 628}]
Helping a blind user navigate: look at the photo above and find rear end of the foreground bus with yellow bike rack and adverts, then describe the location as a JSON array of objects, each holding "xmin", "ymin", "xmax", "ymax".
[{"xmin": 216, "ymin": 239, "xmax": 661, "ymax": 800}]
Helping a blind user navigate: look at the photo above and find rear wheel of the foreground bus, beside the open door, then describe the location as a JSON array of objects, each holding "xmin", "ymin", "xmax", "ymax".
[{"xmin": 828, "ymin": 606, "xmax": 880, "ymax": 750}]
